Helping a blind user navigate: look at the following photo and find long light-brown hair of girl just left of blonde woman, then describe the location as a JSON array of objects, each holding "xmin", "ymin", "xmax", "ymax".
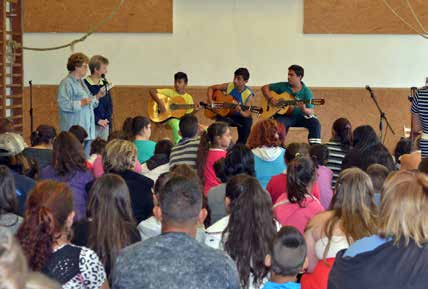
[{"xmin": 330, "ymin": 168, "xmax": 377, "ymax": 243}]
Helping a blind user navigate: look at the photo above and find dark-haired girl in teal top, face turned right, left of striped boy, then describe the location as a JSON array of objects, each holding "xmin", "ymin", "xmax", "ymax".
[{"xmin": 124, "ymin": 116, "xmax": 156, "ymax": 164}]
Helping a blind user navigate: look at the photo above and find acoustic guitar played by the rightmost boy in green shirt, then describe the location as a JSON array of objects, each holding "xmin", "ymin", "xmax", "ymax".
[{"xmin": 261, "ymin": 91, "xmax": 325, "ymax": 119}]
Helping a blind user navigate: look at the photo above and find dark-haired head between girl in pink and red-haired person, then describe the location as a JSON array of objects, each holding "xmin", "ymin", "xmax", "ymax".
[{"xmin": 224, "ymin": 144, "xmax": 256, "ymax": 178}]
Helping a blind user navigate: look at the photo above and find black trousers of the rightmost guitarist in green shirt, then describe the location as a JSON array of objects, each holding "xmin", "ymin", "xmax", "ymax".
[{"xmin": 274, "ymin": 114, "xmax": 321, "ymax": 144}]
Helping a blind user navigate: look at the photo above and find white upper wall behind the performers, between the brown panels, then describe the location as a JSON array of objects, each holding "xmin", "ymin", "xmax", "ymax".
[{"xmin": 24, "ymin": 0, "xmax": 428, "ymax": 87}]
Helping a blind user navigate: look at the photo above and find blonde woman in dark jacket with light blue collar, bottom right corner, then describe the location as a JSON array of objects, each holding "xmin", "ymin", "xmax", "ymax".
[{"xmin": 328, "ymin": 171, "xmax": 428, "ymax": 289}]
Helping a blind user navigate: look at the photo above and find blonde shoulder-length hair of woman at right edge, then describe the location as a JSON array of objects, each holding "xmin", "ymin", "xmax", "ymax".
[{"xmin": 378, "ymin": 171, "xmax": 428, "ymax": 246}]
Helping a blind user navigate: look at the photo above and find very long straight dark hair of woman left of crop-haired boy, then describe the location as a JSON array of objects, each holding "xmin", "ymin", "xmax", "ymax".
[{"xmin": 223, "ymin": 174, "xmax": 276, "ymax": 288}]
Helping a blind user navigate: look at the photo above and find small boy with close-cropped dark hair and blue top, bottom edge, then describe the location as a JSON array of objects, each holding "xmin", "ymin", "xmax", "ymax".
[{"xmin": 263, "ymin": 226, "xmax": 308, "ymax": 289}]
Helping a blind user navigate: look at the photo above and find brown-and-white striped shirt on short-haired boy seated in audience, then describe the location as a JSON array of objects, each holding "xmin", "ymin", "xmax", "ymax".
[{"xmin": 169, "ymin": 137, "xmax": 201, "ymax": 169}]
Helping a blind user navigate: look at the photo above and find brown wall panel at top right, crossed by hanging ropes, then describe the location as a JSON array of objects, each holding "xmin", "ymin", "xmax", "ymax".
[{"xmin": 304, "ymin": 0, "xmax": 428, "ymax": 34}]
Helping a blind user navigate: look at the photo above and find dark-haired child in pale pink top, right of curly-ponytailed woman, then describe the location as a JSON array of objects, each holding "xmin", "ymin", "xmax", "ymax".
[{"xmin": 310, "ymin": 144, "xmax": 333, "ymax": 210}]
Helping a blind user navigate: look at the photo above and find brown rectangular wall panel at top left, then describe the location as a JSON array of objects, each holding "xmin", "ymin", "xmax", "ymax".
[{"xmin": 24, "ymin": 0, "xmax": 173, "ymax": 33}]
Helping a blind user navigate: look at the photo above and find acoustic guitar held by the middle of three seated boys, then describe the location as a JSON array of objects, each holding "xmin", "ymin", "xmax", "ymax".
[{"xmin": 201, "ymin": 90, "xmax": 263, "ymax": 119}]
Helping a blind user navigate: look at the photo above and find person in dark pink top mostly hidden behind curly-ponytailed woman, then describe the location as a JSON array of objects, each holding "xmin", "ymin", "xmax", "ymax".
[{"xmin": 266, "ymin": 143, "xmax": 320, "ymax": 204}]
